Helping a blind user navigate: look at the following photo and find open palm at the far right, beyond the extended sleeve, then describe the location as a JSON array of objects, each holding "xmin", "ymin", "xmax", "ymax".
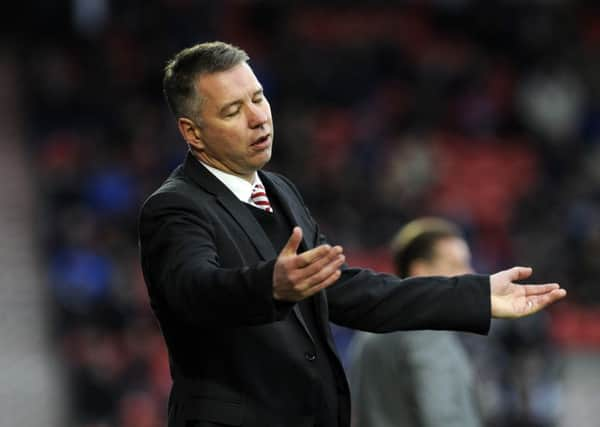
[{"xmin": 490, "ymin": 267, "xmax": 567, "ymax": 319}]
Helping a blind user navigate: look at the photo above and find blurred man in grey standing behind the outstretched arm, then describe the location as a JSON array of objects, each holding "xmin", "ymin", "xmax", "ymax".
[{"xmin": 350, "ymin": 218, "xmax": 481, "ymax": 427}]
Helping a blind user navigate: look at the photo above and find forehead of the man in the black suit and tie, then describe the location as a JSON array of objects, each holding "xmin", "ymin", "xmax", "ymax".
[{"xmin": 196, "ymin": 62, "xmax": 261, "ymax": 106}]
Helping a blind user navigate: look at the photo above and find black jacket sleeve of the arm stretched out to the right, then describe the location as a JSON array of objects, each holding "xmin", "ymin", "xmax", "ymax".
[{"xmin": 274, "ymin": 177, "xmax": 491, "ymax": 334}]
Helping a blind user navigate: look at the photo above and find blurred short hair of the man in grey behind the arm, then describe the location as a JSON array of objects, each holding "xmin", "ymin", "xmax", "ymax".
[{"xmin": 391, "ymin": 217, "xmax": 463, "ymax": 277}]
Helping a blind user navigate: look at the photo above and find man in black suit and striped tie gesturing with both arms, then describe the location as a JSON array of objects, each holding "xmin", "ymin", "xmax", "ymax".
[{"xmin": 139, "ymin": 42, "xmax": 565, "ymax": 427}]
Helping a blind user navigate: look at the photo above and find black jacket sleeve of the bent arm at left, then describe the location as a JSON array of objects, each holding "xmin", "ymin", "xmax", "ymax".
[{"xmin": 139, "ymin": 192, "xmax": 291, "ymax": 327}]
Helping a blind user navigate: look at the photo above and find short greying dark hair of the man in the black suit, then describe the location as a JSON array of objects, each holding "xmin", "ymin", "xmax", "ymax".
[{"xmin": 163, "ymin": 41, "xmax": 250, "ymax": 119}]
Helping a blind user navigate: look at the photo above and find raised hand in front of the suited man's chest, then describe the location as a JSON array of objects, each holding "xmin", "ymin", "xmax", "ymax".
[{"xmin": 273, "ymin": 227, "xmax": 346, "ymax": 302}]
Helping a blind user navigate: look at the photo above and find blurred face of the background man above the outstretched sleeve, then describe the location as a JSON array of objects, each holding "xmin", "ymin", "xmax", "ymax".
[{"xmin": 414, "ymin": 237, "xmax": 473, "ymax": 276}]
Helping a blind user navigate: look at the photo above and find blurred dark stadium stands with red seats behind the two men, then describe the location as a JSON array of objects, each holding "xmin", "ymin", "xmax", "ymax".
[{"xmin": 0, "ymin": 0, "xmax": 600, "ymax": 427}]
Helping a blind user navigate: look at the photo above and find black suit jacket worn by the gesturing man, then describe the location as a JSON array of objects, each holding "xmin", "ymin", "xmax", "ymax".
[{"xmin": 139, "ymin": 154, "xmax": 490, "ymax": 427}]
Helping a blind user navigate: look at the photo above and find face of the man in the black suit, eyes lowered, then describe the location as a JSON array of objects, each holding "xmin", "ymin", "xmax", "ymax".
[{"xmin": 190, "ymin": 62, "xmax": 273, "ymax": 180}]
